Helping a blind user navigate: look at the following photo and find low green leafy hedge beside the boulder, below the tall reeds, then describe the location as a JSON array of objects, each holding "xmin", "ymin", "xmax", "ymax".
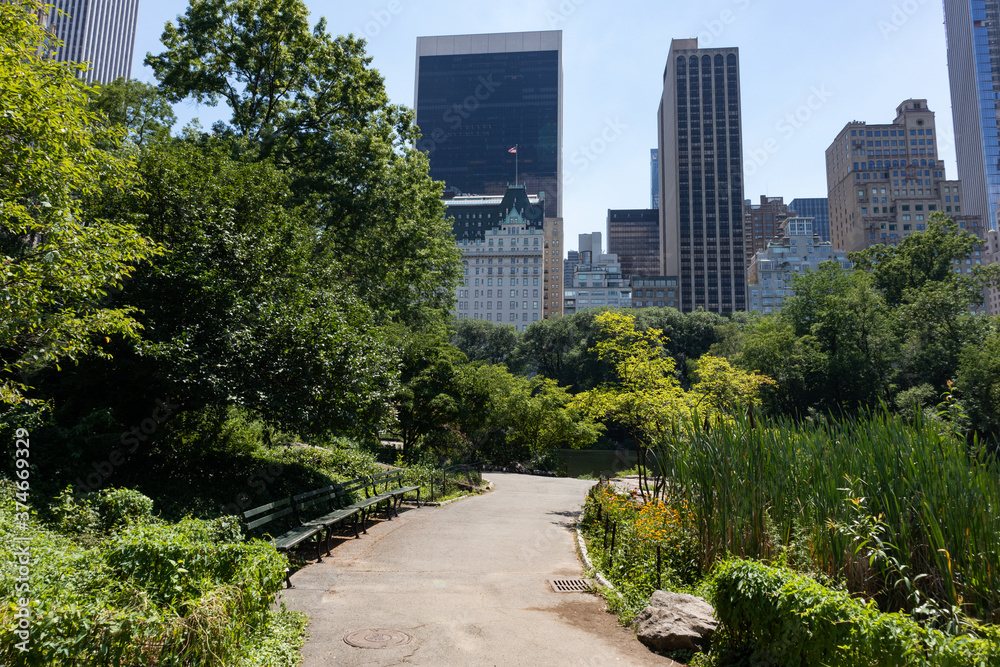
[{"xmin": 713, "ymin": 560, "xmax": 1000, "ymax": 667}]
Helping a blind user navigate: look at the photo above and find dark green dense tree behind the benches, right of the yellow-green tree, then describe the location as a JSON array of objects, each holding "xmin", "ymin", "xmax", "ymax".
[{"xmin": 71, "ymin": 139, "xmax": 398, "ymax": 436}]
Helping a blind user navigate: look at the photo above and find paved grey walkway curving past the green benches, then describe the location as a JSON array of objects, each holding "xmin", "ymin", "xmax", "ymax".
[{"xmin": 283, "ymin": 473, "xmax": 677, "ymax": 667}]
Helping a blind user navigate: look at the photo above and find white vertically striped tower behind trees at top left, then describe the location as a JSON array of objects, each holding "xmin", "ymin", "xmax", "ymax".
[{"xmin": 48, "ymin": 0, "xmax": 139, "ymax": 83}]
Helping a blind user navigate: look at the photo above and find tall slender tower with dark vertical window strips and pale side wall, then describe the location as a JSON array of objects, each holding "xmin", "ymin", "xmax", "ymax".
[{"xmin": 659, "ymin": 39, "xmax": 747, "ymax": 313}]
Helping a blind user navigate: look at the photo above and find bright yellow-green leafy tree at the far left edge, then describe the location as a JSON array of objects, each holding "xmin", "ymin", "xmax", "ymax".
[{"xmin": 0, "ymin": 1, "xmax": 157, "ymax": 404}]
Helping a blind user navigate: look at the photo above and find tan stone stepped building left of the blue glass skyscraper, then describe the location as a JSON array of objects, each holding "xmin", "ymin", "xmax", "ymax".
[{"xmin": 826, "ymin": 100, "xmax": 983, "ymax": 252}]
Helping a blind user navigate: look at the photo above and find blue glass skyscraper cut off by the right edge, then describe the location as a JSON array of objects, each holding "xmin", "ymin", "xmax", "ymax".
[{"xmin": 944, "ymin": 0, "xmax": 1000, "ymax": 231}]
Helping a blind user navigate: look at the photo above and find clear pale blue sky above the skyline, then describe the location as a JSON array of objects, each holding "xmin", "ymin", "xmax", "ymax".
[{"xmin": 132, "ymin": 0, "xmax": 957, "ymax": 256}]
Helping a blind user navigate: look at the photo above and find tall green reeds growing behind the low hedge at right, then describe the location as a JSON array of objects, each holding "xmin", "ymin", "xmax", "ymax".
[{"xmin": 657, "ymin": 413, "xmax": 1000, "ymax": 623}]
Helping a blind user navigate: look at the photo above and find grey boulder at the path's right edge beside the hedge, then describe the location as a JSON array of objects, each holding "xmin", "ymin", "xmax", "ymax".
[{"xmin": 635, "ymin": 591, "xmax": 719, "ymax": 651}]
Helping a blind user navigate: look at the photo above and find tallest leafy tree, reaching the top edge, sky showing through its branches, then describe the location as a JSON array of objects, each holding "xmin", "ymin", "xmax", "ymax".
[{"xmin": 146, "ymin": 0, "xmax": 460, "ymax": 326}]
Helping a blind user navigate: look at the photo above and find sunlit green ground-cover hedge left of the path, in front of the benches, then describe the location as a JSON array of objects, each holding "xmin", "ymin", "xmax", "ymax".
[{"xmin": 0, "ymin": 483, "xmax": 292, "ymax": 667}]
